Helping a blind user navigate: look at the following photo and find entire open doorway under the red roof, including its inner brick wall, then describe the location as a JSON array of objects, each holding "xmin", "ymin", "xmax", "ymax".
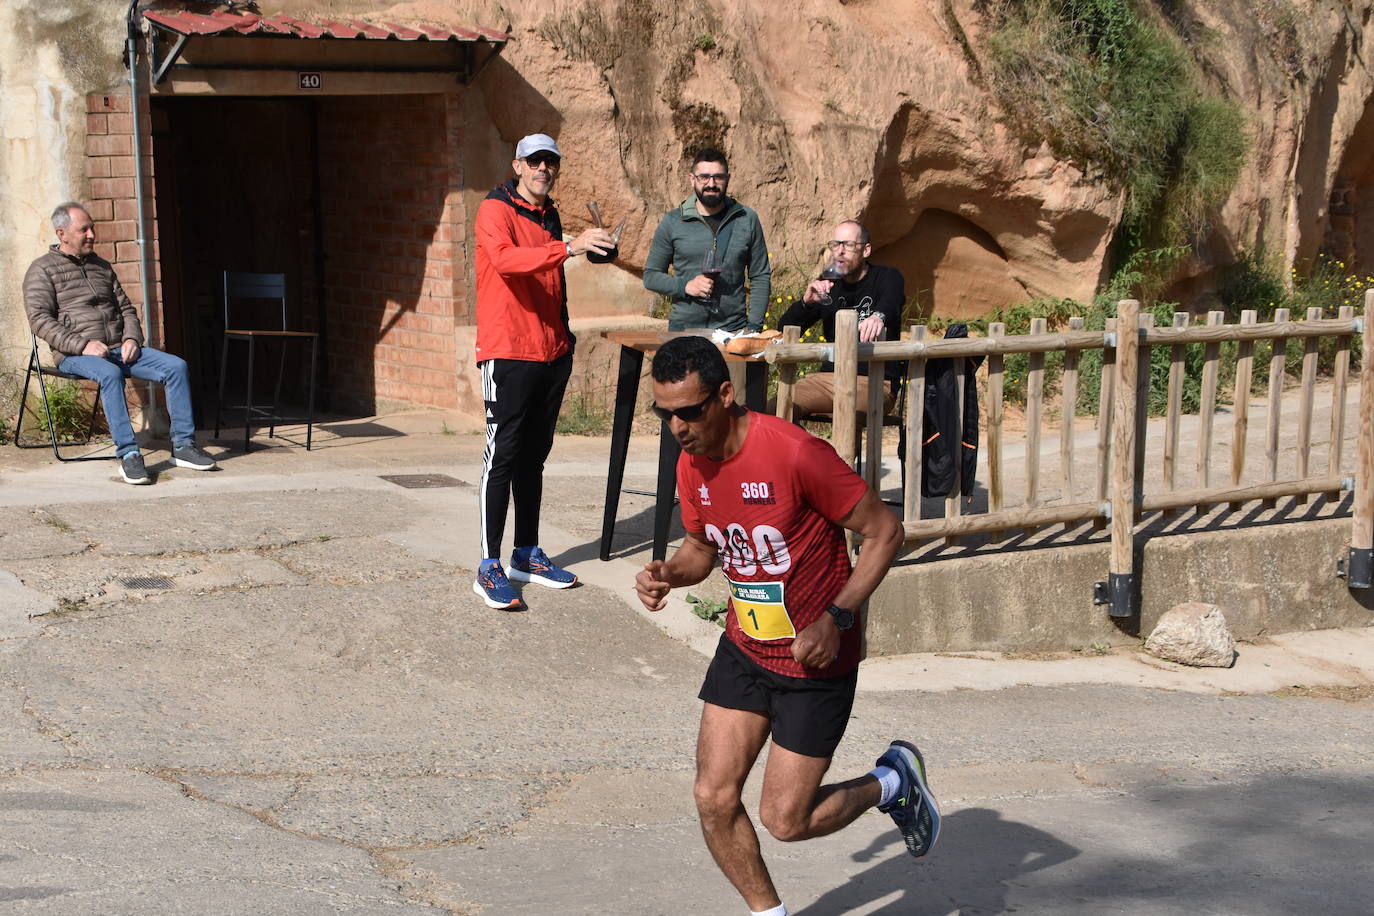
[{"xmin": 153, "ymin": 93, "xmax": 458, "ymax": 419}]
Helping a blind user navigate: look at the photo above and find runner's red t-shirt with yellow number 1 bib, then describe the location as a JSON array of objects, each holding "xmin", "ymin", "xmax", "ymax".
[{"xmin": 677, "ymin": 413, "xmax": 867, "ymax": 677}]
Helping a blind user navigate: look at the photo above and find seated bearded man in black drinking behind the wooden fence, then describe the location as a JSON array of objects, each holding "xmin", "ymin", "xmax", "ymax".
[{"xmin": 778, "ymin": 220, "xmax": 907, "ymax": 420}]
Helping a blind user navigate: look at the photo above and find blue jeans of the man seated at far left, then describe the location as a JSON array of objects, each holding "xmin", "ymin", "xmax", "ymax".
[{"xmin": 58, "ymin": 346, "xmax": 195, "ymax": 457}]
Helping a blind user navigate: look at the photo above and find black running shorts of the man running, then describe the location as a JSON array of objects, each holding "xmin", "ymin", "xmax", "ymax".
[{"xmin": 698, "ymin": 634, "xmax": 859, "ymax": 758}]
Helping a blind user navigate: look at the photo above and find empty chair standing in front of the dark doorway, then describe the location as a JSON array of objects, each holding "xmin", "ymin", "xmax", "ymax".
[{"xmin": 214, "ymin": 271, "xmax": 320, "ymax": 452}]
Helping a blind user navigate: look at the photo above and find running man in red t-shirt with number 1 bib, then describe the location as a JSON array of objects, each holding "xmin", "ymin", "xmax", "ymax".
[{"xmin": 635, "ymin": 336, "xmax": 940, "ymax": 916}]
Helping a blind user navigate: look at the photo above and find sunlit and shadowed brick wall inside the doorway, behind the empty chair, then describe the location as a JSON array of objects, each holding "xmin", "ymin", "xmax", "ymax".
[{"xmin": 320, "ymin": 93, "xmax": 470, "ymax": 409}]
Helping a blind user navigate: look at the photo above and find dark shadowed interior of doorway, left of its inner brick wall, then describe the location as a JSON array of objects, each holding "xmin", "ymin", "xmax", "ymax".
[{"xmin": 153, "ymin": 98, "xmax": 330, "ymax": 426}]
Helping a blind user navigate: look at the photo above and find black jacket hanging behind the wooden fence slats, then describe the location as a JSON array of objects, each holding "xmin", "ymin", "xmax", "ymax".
[{"xmin": 921, "ymin": 324, "xmax": 982, "ymax": 496}]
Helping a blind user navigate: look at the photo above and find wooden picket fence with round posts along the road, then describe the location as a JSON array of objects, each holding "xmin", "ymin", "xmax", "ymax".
[{"xmin": 767, "ymin": 290, "xmax": 1374, "ymax": 617}]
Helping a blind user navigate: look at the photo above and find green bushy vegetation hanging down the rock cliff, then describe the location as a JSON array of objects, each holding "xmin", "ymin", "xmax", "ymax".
[{"xmin": 978, "ymin": 0, "xmax": 1249, "ymax": 248}]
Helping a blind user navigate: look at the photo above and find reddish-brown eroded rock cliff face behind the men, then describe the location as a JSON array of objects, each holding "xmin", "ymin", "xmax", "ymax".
[{"xmin": 368, "ymin": 0, "xmax": 1374, "ymax": 314}]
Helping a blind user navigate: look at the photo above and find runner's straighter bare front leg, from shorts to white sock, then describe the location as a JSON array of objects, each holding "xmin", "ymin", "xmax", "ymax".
[{"xmin": 694, "ymin": 703, "xmax": 782, "ymax": 912}]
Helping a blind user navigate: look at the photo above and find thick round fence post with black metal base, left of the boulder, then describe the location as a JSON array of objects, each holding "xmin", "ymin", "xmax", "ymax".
[{"xmin": 1096, "ymin": 299, "xmax": 1140, "ymax": 617}]
